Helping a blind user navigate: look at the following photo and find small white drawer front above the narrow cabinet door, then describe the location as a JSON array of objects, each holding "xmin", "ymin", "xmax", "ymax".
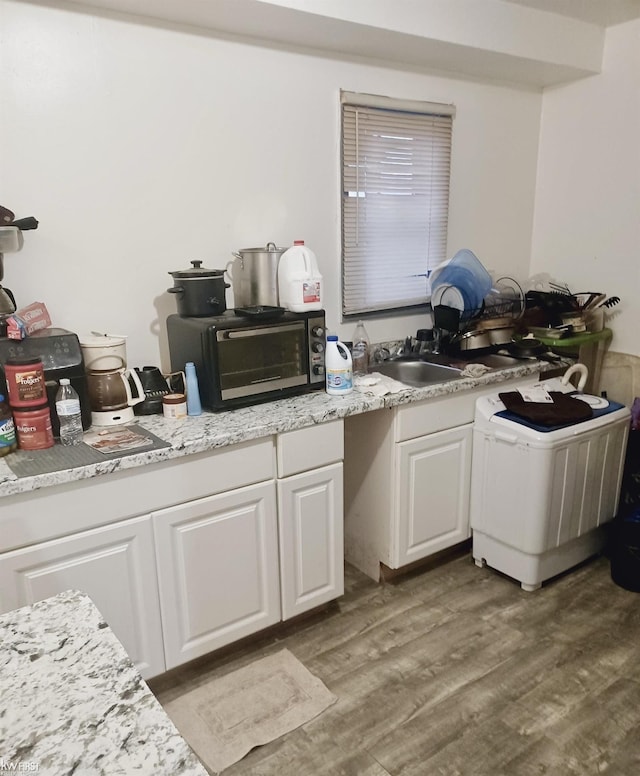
[{"xmin": 276, "ymin": 420, "xmax": 344, "ymax": 477}]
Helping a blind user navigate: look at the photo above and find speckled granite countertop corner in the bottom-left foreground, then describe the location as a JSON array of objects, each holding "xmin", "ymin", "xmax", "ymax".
[{"xmin": 0, "ymin": 591, "xmax": 207, "ymax": 776}]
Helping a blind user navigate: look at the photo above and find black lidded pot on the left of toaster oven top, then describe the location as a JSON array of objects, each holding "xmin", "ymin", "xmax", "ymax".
[{"xmin": 167, "ymin": 261, "xmax": 229, "ymax": 318}]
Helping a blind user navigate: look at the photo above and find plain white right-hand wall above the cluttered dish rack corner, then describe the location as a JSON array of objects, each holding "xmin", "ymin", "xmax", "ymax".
[{"xmin": 531, "ymin": 21, "xmax": 640, "ymax": 355}]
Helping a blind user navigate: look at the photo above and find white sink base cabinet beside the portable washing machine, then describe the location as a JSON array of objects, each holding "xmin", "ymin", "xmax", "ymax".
[{"xmin": 344, "ymin": 376, "xmax": 537, "ymax": 580}]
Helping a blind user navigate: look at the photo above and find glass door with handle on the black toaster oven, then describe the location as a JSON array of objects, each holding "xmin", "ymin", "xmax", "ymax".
[{"xmin": 216, "ymin": 321, "xmax": 309, "ymax": 401}]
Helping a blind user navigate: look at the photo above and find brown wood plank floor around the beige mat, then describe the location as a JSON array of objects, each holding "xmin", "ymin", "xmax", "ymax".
[{"xmin": 150, "ymin": 553, "xmax": 640, "ymax": 776}]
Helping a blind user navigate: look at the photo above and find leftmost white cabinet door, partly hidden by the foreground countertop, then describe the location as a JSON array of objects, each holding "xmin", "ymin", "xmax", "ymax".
[{"xmin": 0, "ymin": 516, "xmax": 164, "ymax": 679}]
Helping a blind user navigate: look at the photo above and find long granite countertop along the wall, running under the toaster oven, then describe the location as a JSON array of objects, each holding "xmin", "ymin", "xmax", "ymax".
[{"xmin": 0, "ymin": 360, "xmax": 548, "ymax": 498}]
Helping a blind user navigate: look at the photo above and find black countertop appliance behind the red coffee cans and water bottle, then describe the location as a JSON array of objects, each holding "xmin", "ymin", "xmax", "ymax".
[{"xmin": 0, "ymin": 327, "xmax": 91, "ymax": 436}]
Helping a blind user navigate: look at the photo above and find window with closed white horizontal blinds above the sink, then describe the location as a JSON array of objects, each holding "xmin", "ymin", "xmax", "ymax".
[{"xmin": 341, "ymin": 92, "xmax": 455, "ymax": 317}]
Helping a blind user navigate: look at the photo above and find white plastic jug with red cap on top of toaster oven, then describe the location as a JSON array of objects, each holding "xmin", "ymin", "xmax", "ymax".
[{"xmin": 278, "ymin": 240, "xmax": 322, "ymax": 313}]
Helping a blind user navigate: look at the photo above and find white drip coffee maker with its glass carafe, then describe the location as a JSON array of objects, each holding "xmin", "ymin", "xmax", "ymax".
[{"xmin": 80, "ymin": 334, "xmax": 145, "ymax": 426}]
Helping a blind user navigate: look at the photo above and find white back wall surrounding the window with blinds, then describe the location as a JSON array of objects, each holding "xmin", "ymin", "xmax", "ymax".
[{"xmin": 0, "ymin": 0, "xmax": 542, "ymax": 366}]
